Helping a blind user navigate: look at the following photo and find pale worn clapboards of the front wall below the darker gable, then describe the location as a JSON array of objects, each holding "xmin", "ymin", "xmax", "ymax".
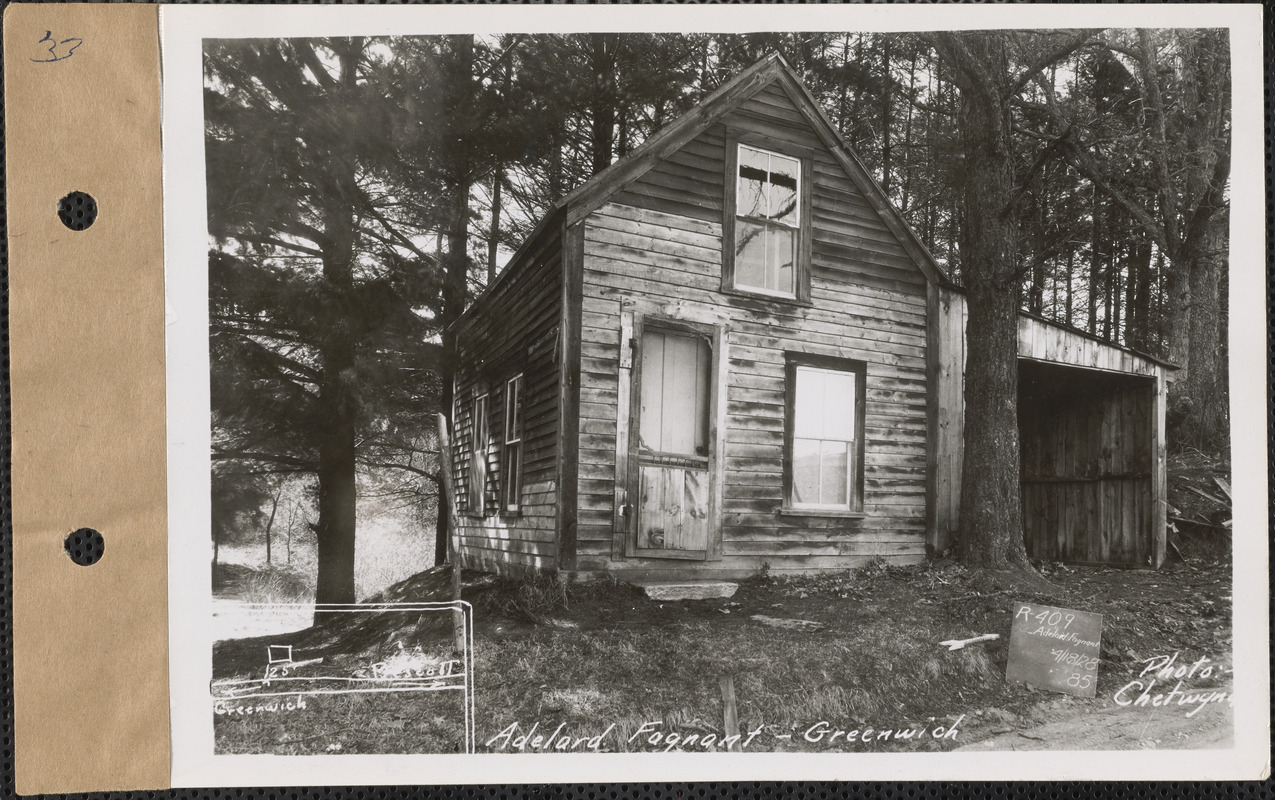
[{"xmin": 578, "ymin": 203, "xmax": 927, "ymax": 575}]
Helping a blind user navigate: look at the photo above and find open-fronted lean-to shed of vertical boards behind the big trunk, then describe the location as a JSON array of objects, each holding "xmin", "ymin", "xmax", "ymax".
[{"xmin": 929, "ymin": 286, "xmax": 1176, "ymax": 567}]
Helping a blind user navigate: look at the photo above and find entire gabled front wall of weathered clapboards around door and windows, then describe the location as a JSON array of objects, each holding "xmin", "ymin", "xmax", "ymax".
[{"xmin": 568, "ymin": 83, "xmax": 927, "ymax": 577}]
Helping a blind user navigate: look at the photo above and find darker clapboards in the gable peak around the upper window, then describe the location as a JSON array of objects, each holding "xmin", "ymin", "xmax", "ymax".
[{"xmin": 612, "ymin": 82, "xmax": 924, "ymax": 297}]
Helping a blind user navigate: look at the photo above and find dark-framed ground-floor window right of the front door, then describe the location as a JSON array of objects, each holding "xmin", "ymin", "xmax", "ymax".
[{"xmin": 784, "ymin": 357, "xmax": 864, "ymax": 513}]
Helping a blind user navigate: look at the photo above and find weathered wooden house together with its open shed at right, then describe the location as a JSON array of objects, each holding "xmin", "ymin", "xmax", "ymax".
[{"xmin": 453, "ymin": 56, "xmax": 1167, "ymax": 581}]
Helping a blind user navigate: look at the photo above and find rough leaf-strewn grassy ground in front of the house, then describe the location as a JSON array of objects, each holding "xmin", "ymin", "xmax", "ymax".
[{"xmin": 214, "ymin": 551, "xmax": 1230, "ymax": 752}]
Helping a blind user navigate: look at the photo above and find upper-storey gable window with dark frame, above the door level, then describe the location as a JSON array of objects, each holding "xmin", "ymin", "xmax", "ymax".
[{"xmin": 724, "ymin": 143, "xmax": 810, "ymax": 300}]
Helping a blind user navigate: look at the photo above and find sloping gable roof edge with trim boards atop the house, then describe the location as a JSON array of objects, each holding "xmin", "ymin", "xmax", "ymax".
[{"xmin": 456, "ymin": 52, "xmax": 950, "ymax": 324}]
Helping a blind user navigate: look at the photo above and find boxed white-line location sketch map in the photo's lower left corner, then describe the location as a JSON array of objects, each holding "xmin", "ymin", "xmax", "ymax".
[{"xmin": 210, "ymin": 602, "xmax": 474, "ymax": 755}]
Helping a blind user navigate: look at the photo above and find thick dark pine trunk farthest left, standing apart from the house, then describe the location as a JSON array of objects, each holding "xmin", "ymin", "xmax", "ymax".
[{"xmin": 315, "ymin": 40, "xmax": 362, "ymax": 624}]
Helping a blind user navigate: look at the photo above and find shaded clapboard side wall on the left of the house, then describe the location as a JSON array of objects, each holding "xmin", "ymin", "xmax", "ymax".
[{"xmin": 453, "ymin": 225, "xmax": 562, "ymax": 575}]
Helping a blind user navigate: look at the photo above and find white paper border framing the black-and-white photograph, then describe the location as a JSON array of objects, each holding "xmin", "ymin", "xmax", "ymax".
[{"xmin": 159, "ymin": 4, "xmax": 1270, "ymax": 787}]
